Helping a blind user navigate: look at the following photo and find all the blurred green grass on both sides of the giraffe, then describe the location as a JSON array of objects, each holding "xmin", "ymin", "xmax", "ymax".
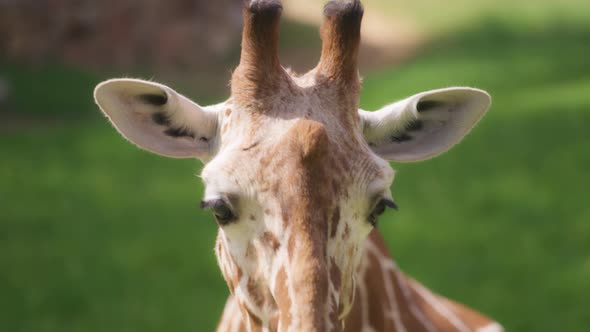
[{"xmin": 0, "ymin": 11, "xmax": 590, "ymax": 332}]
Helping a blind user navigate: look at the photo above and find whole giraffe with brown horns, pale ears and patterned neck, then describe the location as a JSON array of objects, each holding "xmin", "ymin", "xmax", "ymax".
[{"xmin": 95, "ymin": 0, "xmax": 503, "ymax": 332}]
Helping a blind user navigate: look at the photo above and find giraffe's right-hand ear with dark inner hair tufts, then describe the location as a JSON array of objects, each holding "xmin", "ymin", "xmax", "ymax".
[{"xmin": 359, "ymin": 88, "xmax": 491, "ymax": 162}]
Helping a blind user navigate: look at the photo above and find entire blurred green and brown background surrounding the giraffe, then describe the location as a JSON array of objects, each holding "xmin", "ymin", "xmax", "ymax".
[{"xmin": 0, "ymin": 0, "xmax": 590, "ymax": 332}]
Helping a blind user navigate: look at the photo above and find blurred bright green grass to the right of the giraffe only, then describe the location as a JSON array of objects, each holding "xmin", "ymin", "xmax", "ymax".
[{"xmin": 362, "ymin": 19, "xmax": 590, "ymax": 331}]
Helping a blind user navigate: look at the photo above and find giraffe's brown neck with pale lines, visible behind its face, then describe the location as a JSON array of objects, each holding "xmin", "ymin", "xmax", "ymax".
[{"xmin": 217, "ymin": 231, "xmax": 503, "ymax": 332}]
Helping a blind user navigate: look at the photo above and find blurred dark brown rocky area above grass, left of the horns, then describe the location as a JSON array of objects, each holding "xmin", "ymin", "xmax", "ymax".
[{"xmin": 0, "ymin": 0, "xmax": 241, "ymax": 68}]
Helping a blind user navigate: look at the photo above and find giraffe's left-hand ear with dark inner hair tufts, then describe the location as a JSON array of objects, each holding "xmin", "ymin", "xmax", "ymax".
[{"xmin": 94, "ymin": 79, "xmax": 223, "ymax": 160}]
